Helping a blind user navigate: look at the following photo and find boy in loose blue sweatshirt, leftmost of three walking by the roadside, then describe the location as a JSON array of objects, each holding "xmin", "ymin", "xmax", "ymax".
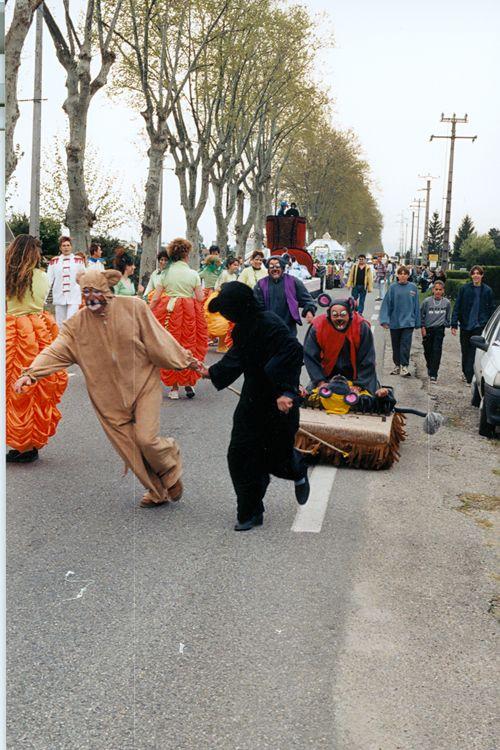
[{"xmin": 379, "ymin": 266, "xmax": 420, "ymax": 378}]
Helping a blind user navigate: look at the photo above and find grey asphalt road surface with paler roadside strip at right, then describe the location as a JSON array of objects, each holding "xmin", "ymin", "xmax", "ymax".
[{"xmin": 7, "ymin": 288, "xmax": 498, "ymax": 750}]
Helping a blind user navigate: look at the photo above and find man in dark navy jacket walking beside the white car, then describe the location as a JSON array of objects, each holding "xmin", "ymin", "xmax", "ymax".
[{"xmin": 451, "ymin": 266, "xmax": 495, "ymax": 383}]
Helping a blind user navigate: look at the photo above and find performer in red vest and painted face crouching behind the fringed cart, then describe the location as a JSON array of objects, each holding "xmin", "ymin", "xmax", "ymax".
[{"xmin": 304, "ymin": 297, "xmax": 387, "ymax": 397}]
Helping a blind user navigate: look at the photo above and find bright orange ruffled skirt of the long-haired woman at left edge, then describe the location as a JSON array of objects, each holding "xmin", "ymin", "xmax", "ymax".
[{"xmin": 5, "ymin": 312, "xmax": 68, "ymax": 451}]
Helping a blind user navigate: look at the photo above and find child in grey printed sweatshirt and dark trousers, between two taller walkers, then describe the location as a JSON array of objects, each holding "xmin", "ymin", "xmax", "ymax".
[{"xmin": 420, "ymin": 281, "xmax": 451, "ymax": 383}]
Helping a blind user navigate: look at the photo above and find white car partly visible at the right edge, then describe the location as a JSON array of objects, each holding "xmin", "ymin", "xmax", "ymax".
[{"xmin": 471, "ymin": 306, "xmax": 500, "ymax": 437}]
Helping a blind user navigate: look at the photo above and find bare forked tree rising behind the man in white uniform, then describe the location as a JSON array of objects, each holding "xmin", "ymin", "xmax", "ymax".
[{"xmin": 43, "ymin": 0, "xmax": 122, "ymax": 250}]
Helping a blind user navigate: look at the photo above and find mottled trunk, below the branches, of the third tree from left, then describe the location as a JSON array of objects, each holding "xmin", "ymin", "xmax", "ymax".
[{"xmin": 139, "ymin": 143, "xmax": 165, "ymax": 279}]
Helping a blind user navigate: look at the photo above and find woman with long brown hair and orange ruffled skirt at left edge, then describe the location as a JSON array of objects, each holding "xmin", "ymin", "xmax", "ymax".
[{"xmin": 5, "ymin": 234, "xmax": 68, "ymax": 463}]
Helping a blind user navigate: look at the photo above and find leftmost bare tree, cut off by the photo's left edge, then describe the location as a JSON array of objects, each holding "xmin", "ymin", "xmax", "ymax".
[{"xmin": 5, "ymin": 0, "xmax": 42, "ymax": 182}]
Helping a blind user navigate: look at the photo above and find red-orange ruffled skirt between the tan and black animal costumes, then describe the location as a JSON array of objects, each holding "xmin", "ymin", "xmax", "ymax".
[{"xmin": 153, "ymin": 294, "xmax": 208, "ymax": 386}]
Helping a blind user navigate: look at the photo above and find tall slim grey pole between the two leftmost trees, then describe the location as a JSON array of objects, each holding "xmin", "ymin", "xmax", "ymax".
[{"xmin": 29, "ymin": 5, "xmax": 43, "ymax": 237}]
